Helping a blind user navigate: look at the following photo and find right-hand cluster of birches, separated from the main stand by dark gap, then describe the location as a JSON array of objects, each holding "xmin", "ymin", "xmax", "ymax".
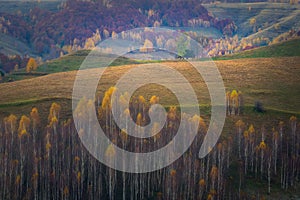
[{"xmin": 234, "ymin": 116, "xmax": 300, "ymax": 197}]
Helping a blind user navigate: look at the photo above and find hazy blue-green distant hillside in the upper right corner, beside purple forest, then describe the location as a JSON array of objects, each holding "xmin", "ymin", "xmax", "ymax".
[{"xmin": 204, "ymin": 2, "xmax": 300, "ymax": 39}]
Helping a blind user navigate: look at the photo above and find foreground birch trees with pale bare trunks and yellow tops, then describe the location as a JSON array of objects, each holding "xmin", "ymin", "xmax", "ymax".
[{"xmin": 0, "ymin": 88, "xmax": 300, "ymax": 199}]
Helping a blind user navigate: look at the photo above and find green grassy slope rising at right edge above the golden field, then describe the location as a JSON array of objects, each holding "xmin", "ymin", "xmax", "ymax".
[{"xmin": 214, "ymin": 38, "xmax": 300, "ymax": 60}]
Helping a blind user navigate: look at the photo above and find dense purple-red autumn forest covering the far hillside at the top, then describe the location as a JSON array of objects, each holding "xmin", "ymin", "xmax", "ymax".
[{"xmin": 0, "ymin": 0, "xmax": 234, "ymax": 58}]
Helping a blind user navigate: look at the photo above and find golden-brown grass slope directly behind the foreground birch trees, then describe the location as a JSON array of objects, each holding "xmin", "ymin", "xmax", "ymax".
[{"xmin": 0, "ymin": 57, "xmax": 300, "ymax": 113}]
